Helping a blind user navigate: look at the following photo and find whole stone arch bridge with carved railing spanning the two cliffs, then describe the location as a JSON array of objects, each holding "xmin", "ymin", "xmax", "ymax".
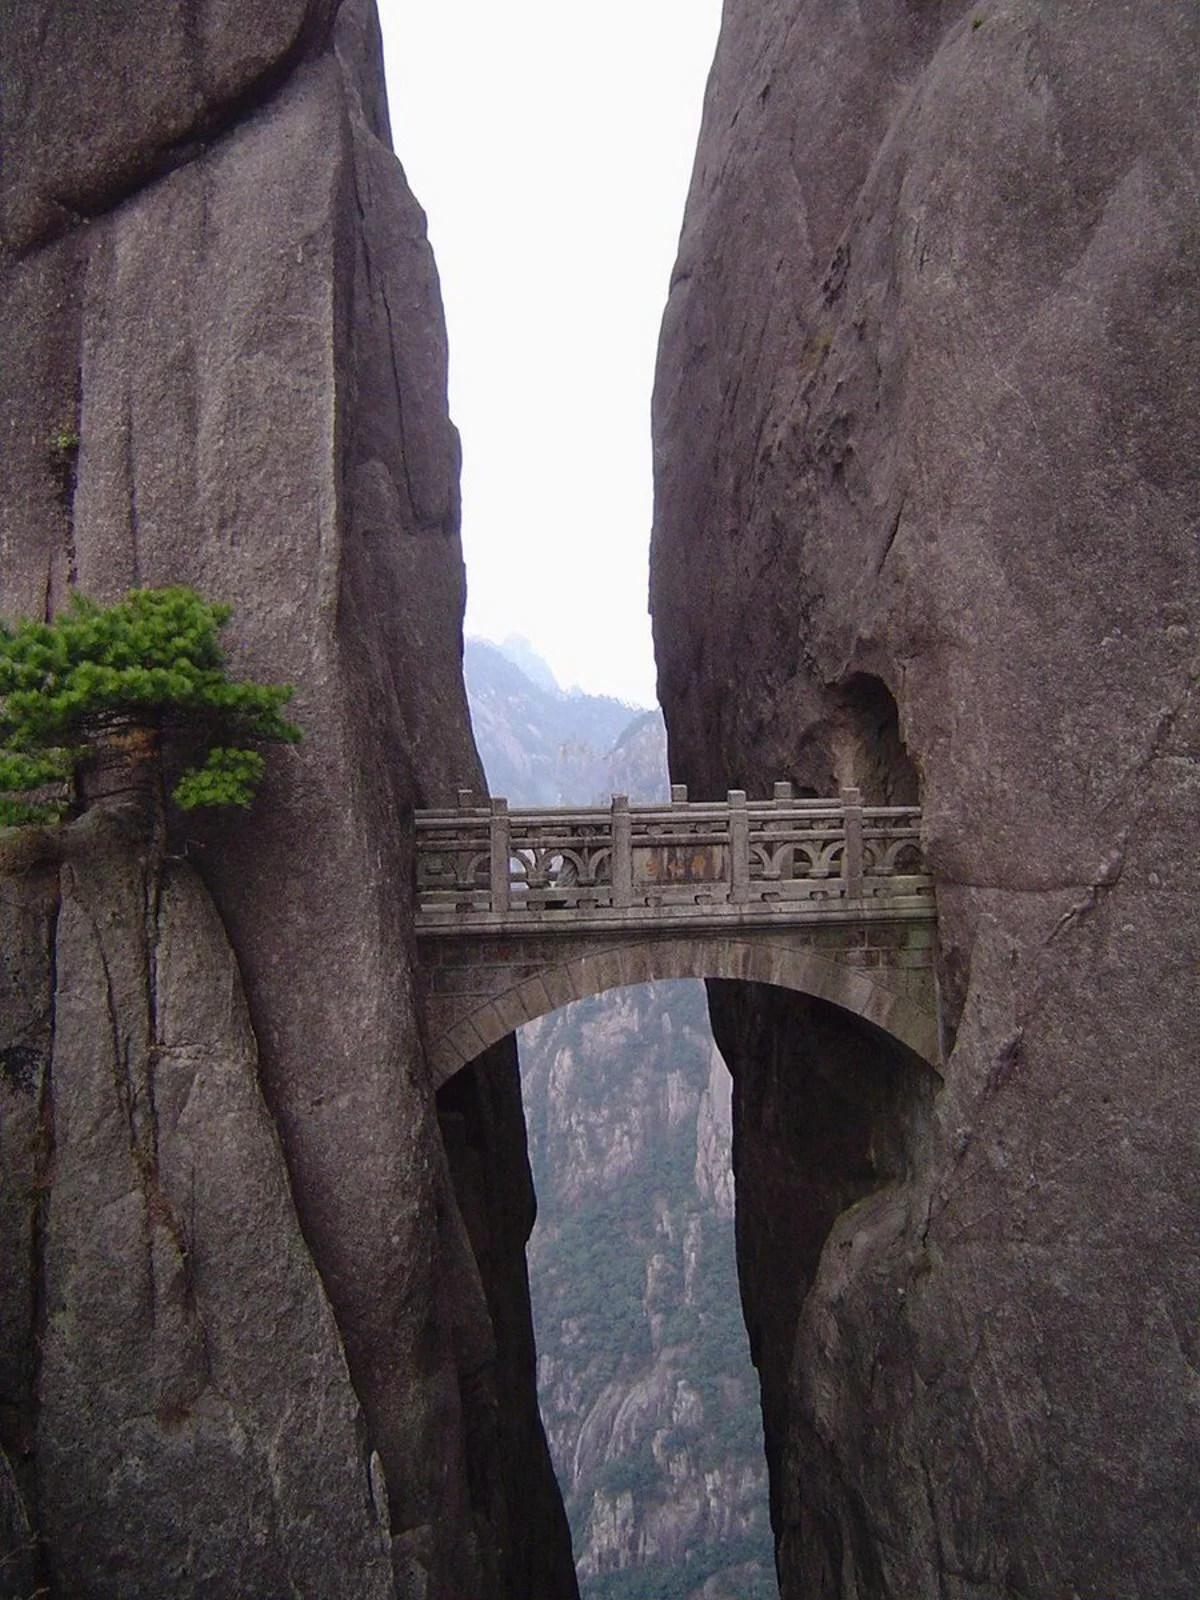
[{"xmin": 416, "ymin": 784, "xmax": 939, "ymax": 1085}]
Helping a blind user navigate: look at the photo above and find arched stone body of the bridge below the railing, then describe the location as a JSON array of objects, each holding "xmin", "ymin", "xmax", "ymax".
[{"xmin": 421, "ymin": 922, "xmax": 939, "ymax": 1088}]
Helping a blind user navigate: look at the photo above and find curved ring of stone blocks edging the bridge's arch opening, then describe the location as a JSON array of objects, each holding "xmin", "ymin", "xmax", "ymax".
[{"xmin": 430, "ymin": 934, "xmax": 939, "ymax": 1085}]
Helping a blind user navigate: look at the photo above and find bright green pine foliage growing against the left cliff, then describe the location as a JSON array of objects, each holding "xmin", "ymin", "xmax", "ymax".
[{"xmin": 0, "ymin": 587, "xmax": 301, "ymax": 826}]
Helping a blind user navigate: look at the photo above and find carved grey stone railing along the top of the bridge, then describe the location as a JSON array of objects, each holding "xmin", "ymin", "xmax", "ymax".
[{"xmin": 416, "ymin": 784, "xmax": 930, "ymax": 925}]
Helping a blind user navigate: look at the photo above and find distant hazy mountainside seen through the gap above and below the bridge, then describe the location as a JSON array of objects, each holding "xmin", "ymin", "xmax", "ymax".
[{"xmin": 466, "ymin": 638, "xmax": 778, "ymax": 1600}]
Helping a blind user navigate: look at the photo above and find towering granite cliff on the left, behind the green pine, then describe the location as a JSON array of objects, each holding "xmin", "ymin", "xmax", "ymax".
[{"xmin": 0, "ymin": 0, "xmax": 574, "ymax": 1600}]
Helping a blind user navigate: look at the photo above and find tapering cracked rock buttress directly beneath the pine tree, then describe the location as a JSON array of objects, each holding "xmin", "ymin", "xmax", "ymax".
[{"xmin": 35, "ymin": 813, "xmax": 392, "ymax": 1600}]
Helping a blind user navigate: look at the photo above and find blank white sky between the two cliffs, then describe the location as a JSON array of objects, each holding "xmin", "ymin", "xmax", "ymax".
[{"xmin": 379, "ymin": 0, "xmax": 720, "ymax": 704}]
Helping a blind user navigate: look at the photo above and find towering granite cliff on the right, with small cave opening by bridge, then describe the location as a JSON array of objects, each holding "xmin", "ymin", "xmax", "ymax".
[{"xmin": 651, "ymin": 0, "xmax": 1200, "ymax": 1600}]
